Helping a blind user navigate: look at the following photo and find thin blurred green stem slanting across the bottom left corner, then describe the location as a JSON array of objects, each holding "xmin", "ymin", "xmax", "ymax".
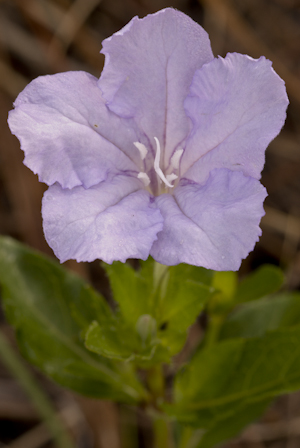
[{"xmin": 0, "ymin": 332, "xmax": 74, "ymax": 448}]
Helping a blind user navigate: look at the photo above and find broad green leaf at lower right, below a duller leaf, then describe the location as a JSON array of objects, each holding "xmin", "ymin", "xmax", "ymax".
[{"xmin": 167, "ymin": 327, "xmax": 300, "ymax": 448}]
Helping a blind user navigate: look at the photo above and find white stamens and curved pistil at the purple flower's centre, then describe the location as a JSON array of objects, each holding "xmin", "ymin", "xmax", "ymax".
[{"xmin": 133, "ymin": 137, "xmax": 183, "ymax": 188}]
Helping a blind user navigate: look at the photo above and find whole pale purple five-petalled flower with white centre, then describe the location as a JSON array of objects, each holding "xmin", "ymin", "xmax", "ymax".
[{"xmin": 9, "ymin": 8, "xmax": 288, "ymax": 270}]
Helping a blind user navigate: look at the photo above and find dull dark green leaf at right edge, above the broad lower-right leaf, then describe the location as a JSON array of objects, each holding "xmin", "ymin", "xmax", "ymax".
[{"xmin": 220, "ymin": 292, "xmax": 300, "ymax": 339}]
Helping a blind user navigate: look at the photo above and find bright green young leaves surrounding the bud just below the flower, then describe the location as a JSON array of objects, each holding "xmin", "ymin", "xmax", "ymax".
[{"xmin": 103, "ymin": 258, "xmax": 215, "ymax": 360}]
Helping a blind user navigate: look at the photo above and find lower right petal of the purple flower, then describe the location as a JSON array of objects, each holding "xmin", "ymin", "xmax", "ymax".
[{"xmin": 150, "ymin": 169, "xmax": 266, "ymax": 271}]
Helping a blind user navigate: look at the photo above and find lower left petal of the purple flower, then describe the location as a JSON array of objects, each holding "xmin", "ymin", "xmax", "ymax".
[{"xmin": 42, "ymin": 175, "xmax": 163, "ymax": 263}]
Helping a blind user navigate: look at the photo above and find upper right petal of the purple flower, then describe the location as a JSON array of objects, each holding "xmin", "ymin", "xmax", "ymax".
[{"xmin": 181, "ymin": 53, "xmax": 288, "ymax": 183}]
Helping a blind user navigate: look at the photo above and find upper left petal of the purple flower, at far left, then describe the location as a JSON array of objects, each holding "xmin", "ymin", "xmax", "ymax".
[{"xmin": 9, "ymin": 72, "xmax": 140, "ymax": 188}]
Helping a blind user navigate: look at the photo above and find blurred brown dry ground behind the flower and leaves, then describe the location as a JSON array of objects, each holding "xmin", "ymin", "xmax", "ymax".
[{"xmin": 0, "ymin": 0, "xmax": 300, "ymax": 448}]
